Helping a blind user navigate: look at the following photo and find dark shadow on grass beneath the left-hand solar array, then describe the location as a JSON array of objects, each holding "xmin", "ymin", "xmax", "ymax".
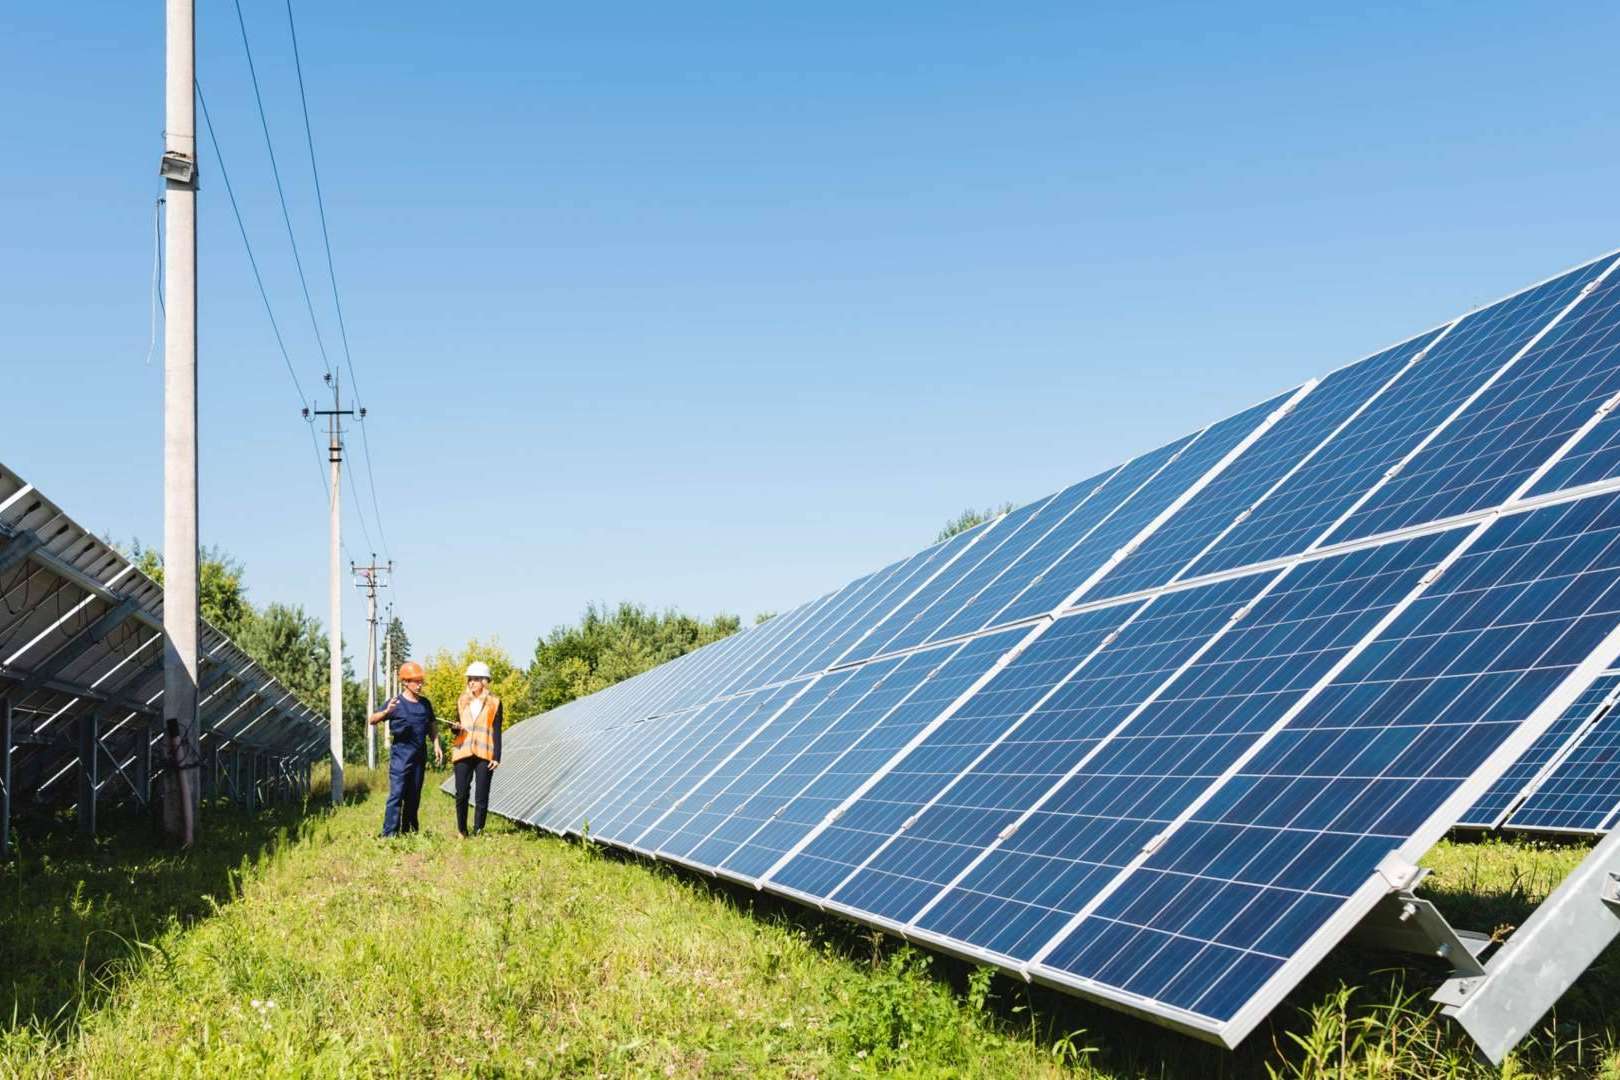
[{"xmin": 0, "ymin": 777, "xmax": 369, "ymax": 1030}]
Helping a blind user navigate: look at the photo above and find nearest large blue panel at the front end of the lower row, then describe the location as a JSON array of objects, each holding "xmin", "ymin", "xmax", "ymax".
[{"xmin": 1047, "ymin": 495, "xmax": 1620, "ymax": 1020}]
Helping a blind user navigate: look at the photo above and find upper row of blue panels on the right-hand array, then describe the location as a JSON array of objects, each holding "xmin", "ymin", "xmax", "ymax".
[{"xmin": 521, "ymin": 247, "xmax": 1620, "ymax": 744}]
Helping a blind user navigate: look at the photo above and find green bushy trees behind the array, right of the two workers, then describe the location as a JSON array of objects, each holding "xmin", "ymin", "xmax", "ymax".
[{"xmin": 527, "ymin": 602, "xmax": 742, "ymax": 714}]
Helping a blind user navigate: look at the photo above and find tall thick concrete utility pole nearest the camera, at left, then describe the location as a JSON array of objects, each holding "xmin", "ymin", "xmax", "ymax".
[{"xmin": 159, "ymin": 0, "xmax": 201, "ymax": 847}]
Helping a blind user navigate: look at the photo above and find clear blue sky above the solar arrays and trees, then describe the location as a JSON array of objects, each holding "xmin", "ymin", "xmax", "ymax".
[{"xmin": 0, "ymin": 0, "xmax": 1620, "ymax": 657}]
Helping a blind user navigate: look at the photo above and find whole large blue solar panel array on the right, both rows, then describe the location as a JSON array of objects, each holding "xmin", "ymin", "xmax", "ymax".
[{"xmin": 473, "ymin": 256, "xmax": 1620, "ymax": 1044}]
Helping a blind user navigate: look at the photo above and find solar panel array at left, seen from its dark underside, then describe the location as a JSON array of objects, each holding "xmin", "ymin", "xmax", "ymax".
[{"xmin": 0, "ymin": 468, "xmax": 327, "ymax": 827}]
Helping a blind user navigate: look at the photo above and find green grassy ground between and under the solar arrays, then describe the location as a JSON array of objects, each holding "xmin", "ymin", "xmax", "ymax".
[{"xmin": 0, "ymin": 774, "xmax": 1620, "ymax": 1080}]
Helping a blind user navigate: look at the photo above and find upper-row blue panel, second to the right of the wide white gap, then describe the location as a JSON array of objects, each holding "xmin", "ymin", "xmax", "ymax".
[{"xmin": 1191, "ymin": 262, "xmax": 1604, "ymax": 575}]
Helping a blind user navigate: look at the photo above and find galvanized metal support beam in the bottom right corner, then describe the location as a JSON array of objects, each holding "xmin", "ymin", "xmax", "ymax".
[{"xmin": 1434, "ymin": 831, "xmax": 1620, "ymax": 1065}]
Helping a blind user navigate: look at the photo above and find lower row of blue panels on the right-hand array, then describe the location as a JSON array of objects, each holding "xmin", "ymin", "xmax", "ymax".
[{"xmin": 496, "ymin": 495, "xmax": 1620, "ymax": 1027}]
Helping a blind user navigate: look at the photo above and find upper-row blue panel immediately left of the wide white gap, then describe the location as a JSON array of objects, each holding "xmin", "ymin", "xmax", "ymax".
[{"xmin": 988, "ymin": 393, "xmax": 1293, "ymax": 625}]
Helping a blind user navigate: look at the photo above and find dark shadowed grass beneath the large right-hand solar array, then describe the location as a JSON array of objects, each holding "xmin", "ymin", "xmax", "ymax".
[{"xmin": 541, "ymin": 826, "xmax": 1620, "ymax": 1080}]
